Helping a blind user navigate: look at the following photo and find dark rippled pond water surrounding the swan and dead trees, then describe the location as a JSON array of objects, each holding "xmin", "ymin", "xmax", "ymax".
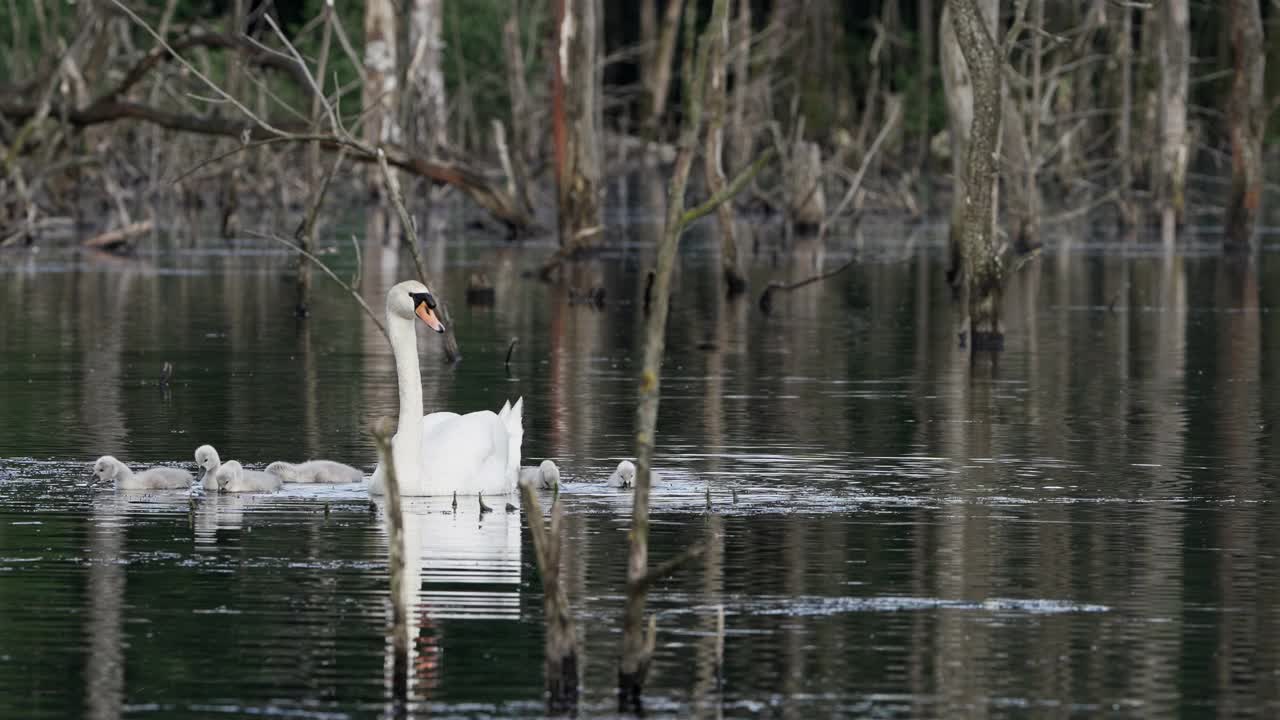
[{"xmin": 0, "ymin": 213, "xmax": 1280, "ymax": 719}]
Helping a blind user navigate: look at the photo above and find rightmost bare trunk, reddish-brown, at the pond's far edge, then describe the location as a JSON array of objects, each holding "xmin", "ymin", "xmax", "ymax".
[{"xmin": 1224, "ymin": 0, "xmax": 1266, "ymax": 250}]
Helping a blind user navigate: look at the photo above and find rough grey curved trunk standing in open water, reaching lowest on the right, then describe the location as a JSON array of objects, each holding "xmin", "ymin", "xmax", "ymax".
[{"xmin": 951, "ymin": 0, "xmax": 1004, "ymax": 350}]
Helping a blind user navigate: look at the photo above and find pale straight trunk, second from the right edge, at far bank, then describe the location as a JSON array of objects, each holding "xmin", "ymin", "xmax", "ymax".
[{"xmin": 1151, "ymin": 0, "xmax": 1190, "ymax": 246}]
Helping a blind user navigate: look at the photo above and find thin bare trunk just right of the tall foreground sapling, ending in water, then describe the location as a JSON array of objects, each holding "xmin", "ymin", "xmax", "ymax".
[{"xmin": 703, "ymin": 0, "xmax": 746, "ymax": 295}]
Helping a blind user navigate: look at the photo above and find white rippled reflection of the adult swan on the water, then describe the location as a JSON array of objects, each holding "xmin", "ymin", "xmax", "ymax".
[{"xmin": 375, "ymin": 489, "xmax": 521, "ymax": 700}]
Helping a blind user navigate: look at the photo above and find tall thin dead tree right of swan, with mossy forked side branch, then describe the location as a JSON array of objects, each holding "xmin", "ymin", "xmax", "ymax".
[{"xmin": 618, "ymin": 0, "xmax": 771, "ymax": 710}]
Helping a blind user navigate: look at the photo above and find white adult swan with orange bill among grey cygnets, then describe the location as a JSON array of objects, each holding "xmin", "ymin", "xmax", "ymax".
[{"xmin": 369, "ymin": 281, "xmax": 524, "ymax": 496}]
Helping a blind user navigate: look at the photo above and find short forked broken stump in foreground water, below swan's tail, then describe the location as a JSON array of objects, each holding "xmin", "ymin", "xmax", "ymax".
[{"xmin": 520, "ymin": 483, "xmax": 579, "ymax": 712}]
